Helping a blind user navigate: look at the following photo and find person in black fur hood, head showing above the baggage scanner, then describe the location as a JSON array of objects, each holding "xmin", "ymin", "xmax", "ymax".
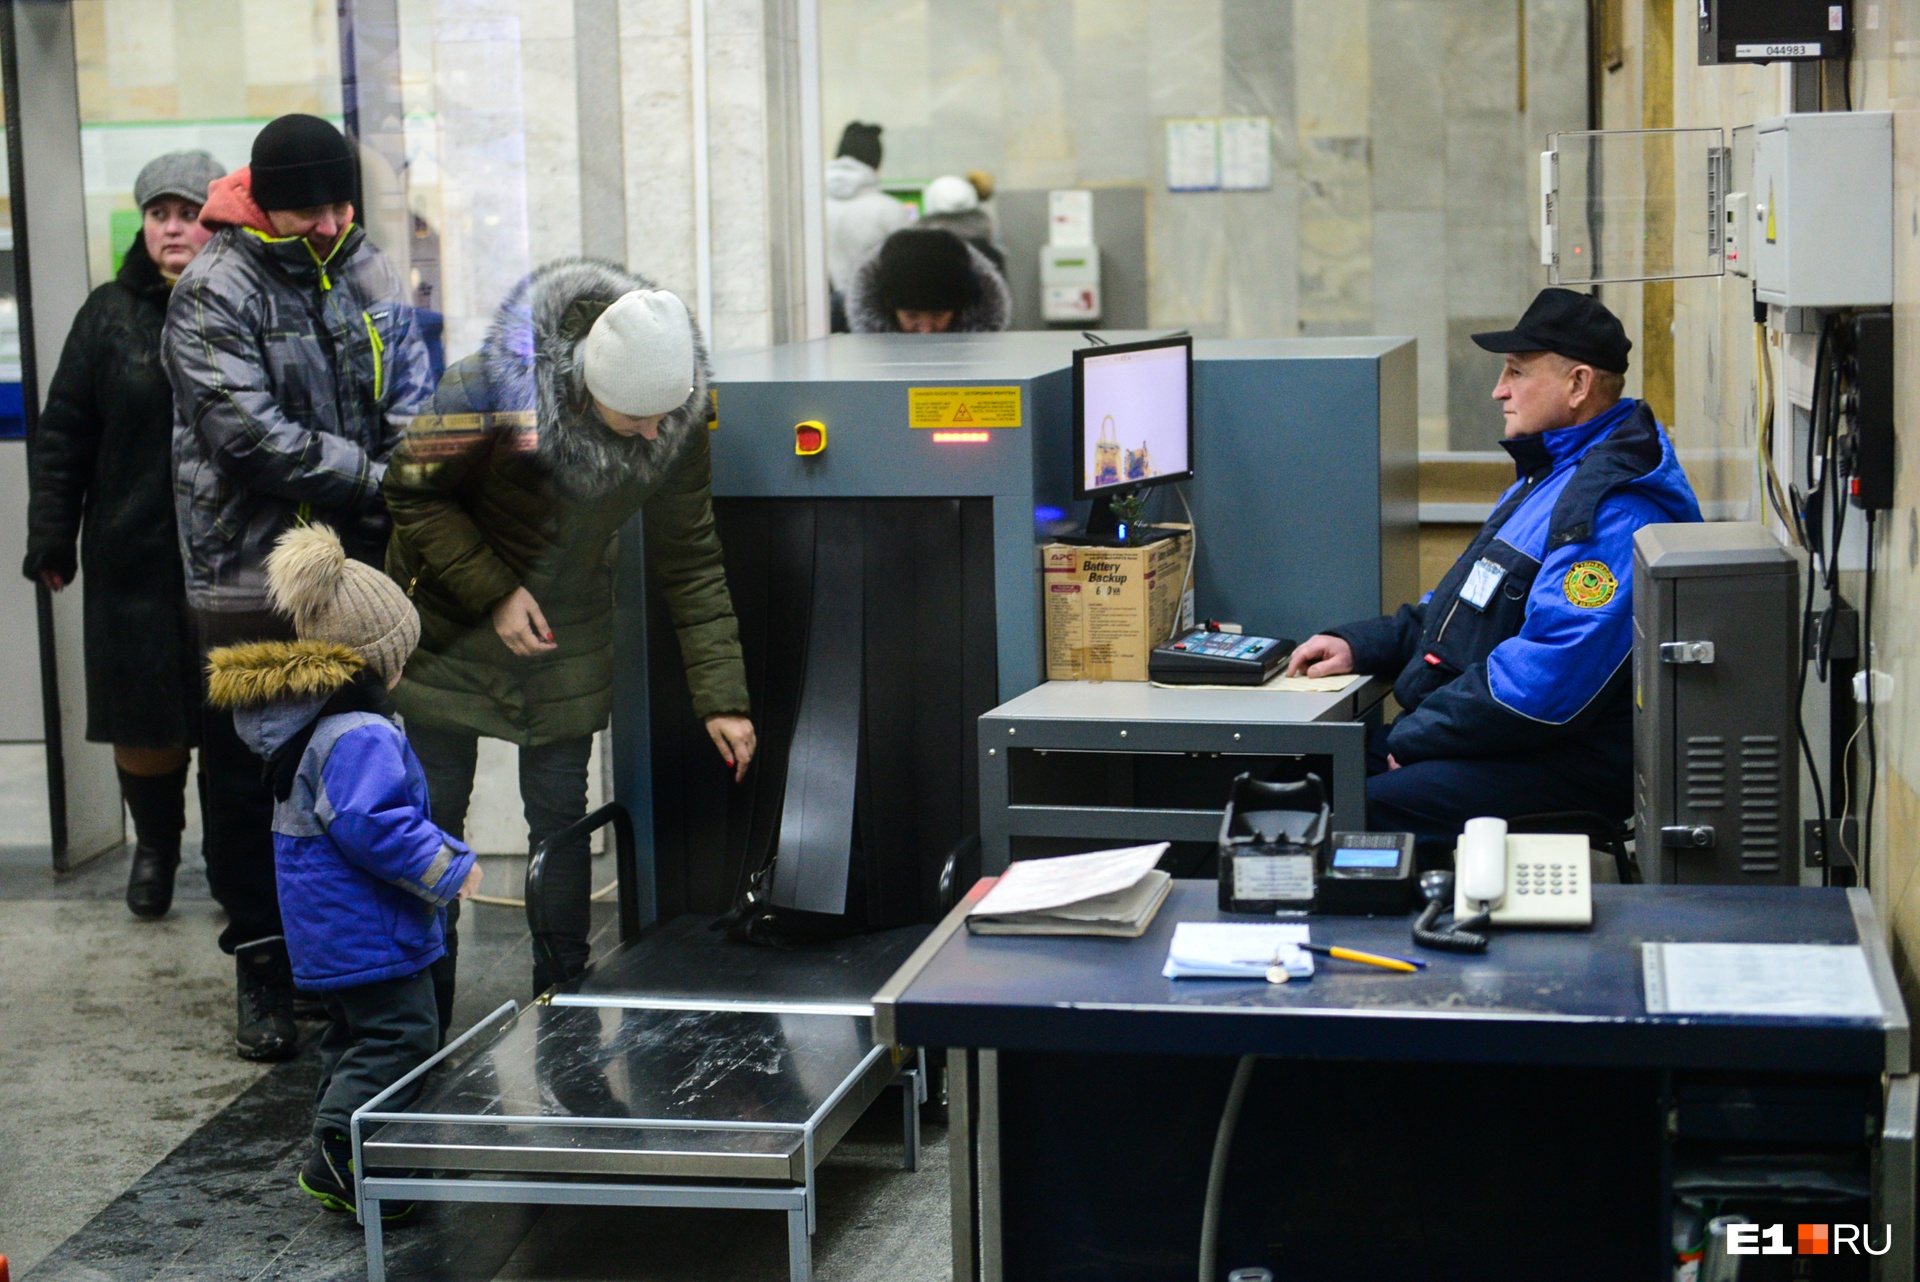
[{"xmin": 847, "ymin": 226, "xmax": 1014, "ymax": 334}]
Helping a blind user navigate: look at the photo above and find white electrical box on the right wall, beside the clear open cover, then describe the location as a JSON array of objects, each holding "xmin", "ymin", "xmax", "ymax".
[{"xmin": 1740, "ymin": 111, "xmax": 1893, "ymax": 307}]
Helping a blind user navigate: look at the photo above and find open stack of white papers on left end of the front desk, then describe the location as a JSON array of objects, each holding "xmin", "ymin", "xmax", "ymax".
[{"xmin": 966, "ymin": 841, "xmax": 1173, "ymax": 938}]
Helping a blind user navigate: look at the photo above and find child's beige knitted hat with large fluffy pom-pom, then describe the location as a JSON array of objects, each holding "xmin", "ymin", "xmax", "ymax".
[{"xmin": 267, "ymin": 526, "xmax": 420, "ymax": 681}]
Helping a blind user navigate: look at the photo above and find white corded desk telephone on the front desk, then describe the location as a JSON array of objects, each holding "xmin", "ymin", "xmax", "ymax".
[{"xmin": 1453, "ymin": 819, "xmax": 1594, "ymax": 927}]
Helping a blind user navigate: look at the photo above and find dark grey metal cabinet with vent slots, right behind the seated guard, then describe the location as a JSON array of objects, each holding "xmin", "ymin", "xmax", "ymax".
[{"xmin": 1634, "ymin": 522, "xmax": 1799, "ymax": 885}]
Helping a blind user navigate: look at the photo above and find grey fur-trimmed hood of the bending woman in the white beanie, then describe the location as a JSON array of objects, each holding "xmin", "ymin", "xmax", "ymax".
[{"xmin": 480, "ymin": 257, "xmax": 708, "ymax": 501}]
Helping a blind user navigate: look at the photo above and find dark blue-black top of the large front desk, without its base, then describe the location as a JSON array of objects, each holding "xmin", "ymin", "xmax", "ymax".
[{"xmin": 877, "ymin": 881, "xmax": 1908, "ymax": 1073}]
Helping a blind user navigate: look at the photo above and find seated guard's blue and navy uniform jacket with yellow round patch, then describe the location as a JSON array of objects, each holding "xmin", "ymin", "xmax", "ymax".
[{"xmin": 1331, "ymin": 399, "xmax": 1701, "ymax": 770}]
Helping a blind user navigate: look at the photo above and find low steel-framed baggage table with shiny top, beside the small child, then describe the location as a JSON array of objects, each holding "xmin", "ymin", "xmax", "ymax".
[{"xmin": 351, "ymin": 994, "xmax": 927, "ymax": 1282}]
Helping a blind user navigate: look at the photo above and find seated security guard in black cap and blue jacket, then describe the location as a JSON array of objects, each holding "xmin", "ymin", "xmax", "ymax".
[{"xmin": 1286, "ymin": 290, "xmax": 1701, "ymax": 866}]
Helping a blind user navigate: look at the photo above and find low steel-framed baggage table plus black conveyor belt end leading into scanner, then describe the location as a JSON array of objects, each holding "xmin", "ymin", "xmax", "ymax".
[{"xmin": 351, "ymin": 809, "xmax": 929, "ymax": 1282}]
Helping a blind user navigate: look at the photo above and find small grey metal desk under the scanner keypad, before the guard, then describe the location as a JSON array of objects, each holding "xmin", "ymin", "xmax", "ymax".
[{"xmin": 979, "ymin": 677, "xmax": 1390, "ymax": 875}]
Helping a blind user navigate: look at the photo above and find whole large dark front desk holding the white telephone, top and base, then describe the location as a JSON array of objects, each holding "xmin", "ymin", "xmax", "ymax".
[{"xmin": 876, "ymin": 881, "xmax": 1916, "ymax": 1282}]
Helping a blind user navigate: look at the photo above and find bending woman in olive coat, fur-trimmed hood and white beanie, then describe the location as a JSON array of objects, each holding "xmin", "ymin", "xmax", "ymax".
[{"xmin": 386, "ymin": 259, "xmax": 755, "ymax": 1004}]
